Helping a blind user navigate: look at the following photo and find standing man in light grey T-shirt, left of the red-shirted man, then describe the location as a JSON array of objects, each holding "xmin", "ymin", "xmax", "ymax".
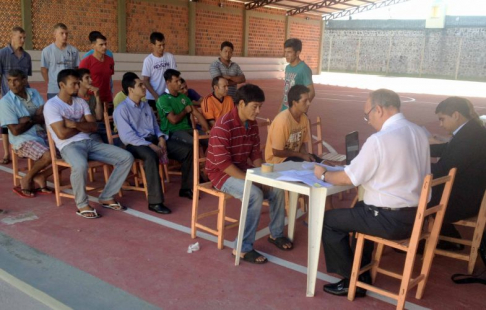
[{"xmin": 41, "ymin": 23, "xmax": 79, "ymax": 100}]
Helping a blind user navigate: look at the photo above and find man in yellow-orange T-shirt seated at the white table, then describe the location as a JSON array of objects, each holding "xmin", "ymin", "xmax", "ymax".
[{"xmin": 265, "ymin": 85, "xmax": 315, "ymax": 164}]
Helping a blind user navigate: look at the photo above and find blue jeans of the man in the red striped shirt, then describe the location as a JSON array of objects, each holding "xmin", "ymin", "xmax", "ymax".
[{"xmin": 221, "ymin": 177, "xmax": 285, "ymax": 253}]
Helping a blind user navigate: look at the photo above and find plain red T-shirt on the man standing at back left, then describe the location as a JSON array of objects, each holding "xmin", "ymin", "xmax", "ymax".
[{"xmin": 79, "ymin": 55, "xmax": 115, "ymax": 102}]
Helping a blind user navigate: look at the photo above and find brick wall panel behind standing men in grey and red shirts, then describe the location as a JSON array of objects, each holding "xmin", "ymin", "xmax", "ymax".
[{"xmin": 31, "ymin": 0, "xmax": 118, "ymax": 52}]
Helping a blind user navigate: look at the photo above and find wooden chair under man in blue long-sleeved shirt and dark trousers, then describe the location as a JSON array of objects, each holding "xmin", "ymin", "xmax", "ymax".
[{"xmin": 103, "ymin": 111, "xmax": 159, "ymax": 197}]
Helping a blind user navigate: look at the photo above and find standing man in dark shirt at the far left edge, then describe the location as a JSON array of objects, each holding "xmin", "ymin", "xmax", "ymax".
[{"xmin": 0, "ymin": 26, "xmax": 32, "ymax": 165}]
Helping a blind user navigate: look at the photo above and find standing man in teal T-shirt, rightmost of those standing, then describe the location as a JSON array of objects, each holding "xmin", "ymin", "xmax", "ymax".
[{"xmin": 279, "ymin": 39, "xmax": 316, "ymax": 111}]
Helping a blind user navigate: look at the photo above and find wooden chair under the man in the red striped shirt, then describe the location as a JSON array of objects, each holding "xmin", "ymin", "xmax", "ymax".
[{"xmin": 191, "ymin": 130, "xmax": 238, "ymax": 250}]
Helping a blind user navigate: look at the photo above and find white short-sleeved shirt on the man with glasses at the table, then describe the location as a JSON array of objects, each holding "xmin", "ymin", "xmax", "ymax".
[{"xmin": 344, "ymin": 113, "xmax": 430, "ymax": 208}]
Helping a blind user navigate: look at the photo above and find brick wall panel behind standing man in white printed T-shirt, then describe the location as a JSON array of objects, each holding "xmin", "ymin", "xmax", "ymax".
[{"xmin": 127, "ymin": 0, "xmax": 189, "ymax": 55}]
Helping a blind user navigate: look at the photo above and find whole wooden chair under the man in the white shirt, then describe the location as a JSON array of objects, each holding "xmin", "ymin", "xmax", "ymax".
[{"xmin": 348, "ymin": 168, "xmax": 457, "ymax": 309}]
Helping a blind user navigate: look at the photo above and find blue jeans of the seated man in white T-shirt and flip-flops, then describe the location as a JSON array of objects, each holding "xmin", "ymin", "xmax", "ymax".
[{"xmin": 61, "ymin": 139, "xmax": 133, "ymax": 209}]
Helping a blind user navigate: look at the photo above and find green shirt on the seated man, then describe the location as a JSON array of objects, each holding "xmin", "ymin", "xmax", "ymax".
[{"xmin": 156, "ymin": 93, "xmax": 192, "ymax": 135}]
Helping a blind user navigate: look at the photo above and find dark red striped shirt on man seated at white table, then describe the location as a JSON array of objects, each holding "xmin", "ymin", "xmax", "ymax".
[{"xmin": 206, "ymin": 107, "xmax": 262, "ymax": 189}]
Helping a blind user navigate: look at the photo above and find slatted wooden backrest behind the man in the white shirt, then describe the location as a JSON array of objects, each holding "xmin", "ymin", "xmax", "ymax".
[{"xmin": 410, "ymin": 168, "xmax": 457, "ymax": 247}]
